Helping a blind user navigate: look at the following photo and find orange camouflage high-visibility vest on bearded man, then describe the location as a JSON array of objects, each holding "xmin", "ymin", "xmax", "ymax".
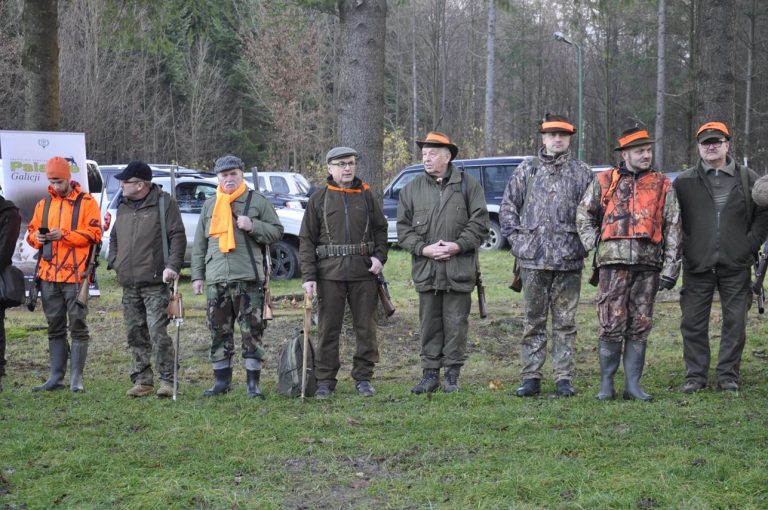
[{"xmin": 597, "ymin": 168, "xmax": 671, "ymax": 244}]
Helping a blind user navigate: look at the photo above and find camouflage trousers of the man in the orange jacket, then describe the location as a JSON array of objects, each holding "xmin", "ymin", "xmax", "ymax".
[{"xmin": 40, "ymin": 281, "xmax": 90, "ymax": 342}]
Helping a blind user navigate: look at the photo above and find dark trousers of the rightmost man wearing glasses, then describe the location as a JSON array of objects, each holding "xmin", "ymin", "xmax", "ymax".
[{"xmin": 680, "ymin": 267, "xmax": 752, "ymax": 384}]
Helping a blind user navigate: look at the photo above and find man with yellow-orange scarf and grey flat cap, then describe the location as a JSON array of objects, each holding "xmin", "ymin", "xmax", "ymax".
[{"xmin": 192, "ymin": 155, "xmax": 283, "ymax": 398}]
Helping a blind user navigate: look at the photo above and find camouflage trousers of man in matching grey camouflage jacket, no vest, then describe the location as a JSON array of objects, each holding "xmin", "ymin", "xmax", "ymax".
[{"xmin": 520, "ymin": 268, "xmax": 581, "ymax": 381}]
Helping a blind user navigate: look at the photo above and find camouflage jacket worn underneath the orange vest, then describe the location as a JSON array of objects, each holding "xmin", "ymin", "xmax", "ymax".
[{"xmin": 576, "ymin": 169, "xmax": 682, "ymax": 280}]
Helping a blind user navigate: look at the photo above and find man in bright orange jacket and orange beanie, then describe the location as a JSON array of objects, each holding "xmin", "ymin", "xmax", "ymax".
[{"xmin": 27, "ymin": 156, "xmax": 101, "ymax": 391}]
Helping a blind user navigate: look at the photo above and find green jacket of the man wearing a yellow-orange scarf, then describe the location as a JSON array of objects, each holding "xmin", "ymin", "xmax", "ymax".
[{"xmin": 192, "ymin": 191, "xmax": 283, "ymax": 285}]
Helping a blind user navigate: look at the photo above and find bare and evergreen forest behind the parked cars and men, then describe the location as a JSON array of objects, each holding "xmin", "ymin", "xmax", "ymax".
[{"xmin": 0, "ymin": 0, "xmax": 768, "ymax": 189}]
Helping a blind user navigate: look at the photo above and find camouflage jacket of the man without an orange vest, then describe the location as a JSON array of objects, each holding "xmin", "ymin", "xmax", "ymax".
[{"xmin": 499, "ymin": 148, "xmax": 592, "ymax": 271}]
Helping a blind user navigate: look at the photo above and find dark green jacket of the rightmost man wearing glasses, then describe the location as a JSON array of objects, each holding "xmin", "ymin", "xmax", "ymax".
[{"xmin": 672, "ymin": 156, "xmax": 768, "ymax": 273}]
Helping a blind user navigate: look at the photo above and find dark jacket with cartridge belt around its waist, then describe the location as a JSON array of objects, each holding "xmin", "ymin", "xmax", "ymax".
[{"xmin": 299, "ymin": 177, "xmax": 387, "ymax": 282}]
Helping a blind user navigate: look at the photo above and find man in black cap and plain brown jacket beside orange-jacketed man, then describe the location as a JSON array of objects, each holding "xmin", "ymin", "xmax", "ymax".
[{"xmin": 107, "ymin": 161, "xmax": 187, "ymax": 398}]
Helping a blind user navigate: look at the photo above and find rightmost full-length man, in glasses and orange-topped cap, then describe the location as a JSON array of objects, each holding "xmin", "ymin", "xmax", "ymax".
[{"xmin": 673, "ymin": 121, "xmax": 768, "ymax": 393}]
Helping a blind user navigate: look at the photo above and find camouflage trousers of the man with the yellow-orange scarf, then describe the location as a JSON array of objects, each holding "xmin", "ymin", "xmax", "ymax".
[{"xmin": 207, "ymin": 281, "xmax": 265, "ymax": 363}]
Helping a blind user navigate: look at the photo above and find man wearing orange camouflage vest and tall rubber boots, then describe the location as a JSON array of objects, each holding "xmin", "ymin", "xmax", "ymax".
[{"xmin": 576, "ymin": 127, "xmax": 682, "ymax": 400}]
